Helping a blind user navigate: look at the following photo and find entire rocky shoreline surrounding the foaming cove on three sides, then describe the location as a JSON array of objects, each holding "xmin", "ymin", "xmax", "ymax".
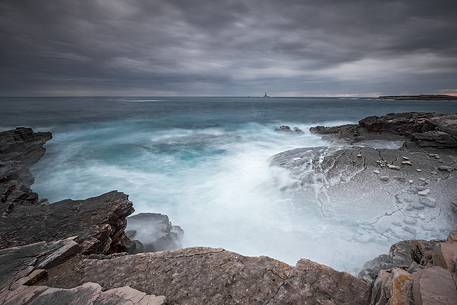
[{"xmin": 0, "ymin": 113, "xmax": 457, "ymax": 305}]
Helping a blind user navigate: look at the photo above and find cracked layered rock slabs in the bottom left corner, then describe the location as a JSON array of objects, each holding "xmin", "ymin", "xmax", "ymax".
[{"xmin": 0, "ymin": 238, "xmax": 165, "ymax": 305}]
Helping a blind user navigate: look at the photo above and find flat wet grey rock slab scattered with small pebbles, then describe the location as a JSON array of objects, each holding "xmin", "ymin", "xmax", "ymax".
[{"xmin": 271, "ymin": 147, "xmax": 457, "ymax": 244}]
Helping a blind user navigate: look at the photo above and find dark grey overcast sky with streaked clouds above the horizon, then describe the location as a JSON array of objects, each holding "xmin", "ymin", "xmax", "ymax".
[{"xmin": 0, "ymin": 0, "xmax": 457, "ymax": 96}]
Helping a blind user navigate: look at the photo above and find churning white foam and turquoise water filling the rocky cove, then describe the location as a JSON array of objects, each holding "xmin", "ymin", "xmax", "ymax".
[{"xmin": 34, "ymin": 122, "xmax": 392, "ymax": 271}]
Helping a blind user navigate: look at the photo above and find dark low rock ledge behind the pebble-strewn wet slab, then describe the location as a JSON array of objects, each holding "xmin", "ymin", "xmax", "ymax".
[{"xmin": 310, "ymin": 112, "xmax": 457, "ymax": 148}]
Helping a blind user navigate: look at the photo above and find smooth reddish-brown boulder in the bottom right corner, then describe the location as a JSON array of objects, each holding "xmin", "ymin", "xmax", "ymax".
[{"xmin": 413, "ymin": 266, "xmax": 457, "ymax": 305}]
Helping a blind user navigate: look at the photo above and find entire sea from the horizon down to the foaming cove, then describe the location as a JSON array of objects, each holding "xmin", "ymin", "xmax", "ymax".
[{"xmin": 0, "ymin": 97, "xmax": 457, "ymax": 272}]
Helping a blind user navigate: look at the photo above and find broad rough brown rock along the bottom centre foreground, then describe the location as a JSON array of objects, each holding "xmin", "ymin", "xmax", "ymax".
[{"xmin": 42, "ymin": 248, "xmax": 370, "ymax": 305}]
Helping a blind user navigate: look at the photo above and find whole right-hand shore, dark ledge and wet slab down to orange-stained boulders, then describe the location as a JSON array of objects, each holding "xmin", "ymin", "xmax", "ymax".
[{"xmin": 302, "ymin": 113, "xmax": 457, "ymax": 305}]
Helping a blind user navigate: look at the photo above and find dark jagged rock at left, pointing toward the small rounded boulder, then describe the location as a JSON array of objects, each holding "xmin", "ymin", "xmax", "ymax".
[{"xmin": 0, "ymin": 191, "xmax": 133, "ymax": 253}]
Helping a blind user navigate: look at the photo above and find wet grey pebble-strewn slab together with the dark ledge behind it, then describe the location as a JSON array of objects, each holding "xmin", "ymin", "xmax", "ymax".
[{"xmin": 271, "ymin": 112, "xmax": 457, "ymax": 243}]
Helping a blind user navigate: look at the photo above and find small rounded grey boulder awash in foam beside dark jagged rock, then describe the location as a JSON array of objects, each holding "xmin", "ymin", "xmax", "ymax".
[{"xmin": 126, "ymin": 213, "xmax": 184, "ymax": 253}]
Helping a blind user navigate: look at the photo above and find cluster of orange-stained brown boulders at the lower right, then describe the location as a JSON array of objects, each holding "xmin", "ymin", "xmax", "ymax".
[{"xmin": 366, "ymin": 231, "xmax": 457, "ymax": 305}]
